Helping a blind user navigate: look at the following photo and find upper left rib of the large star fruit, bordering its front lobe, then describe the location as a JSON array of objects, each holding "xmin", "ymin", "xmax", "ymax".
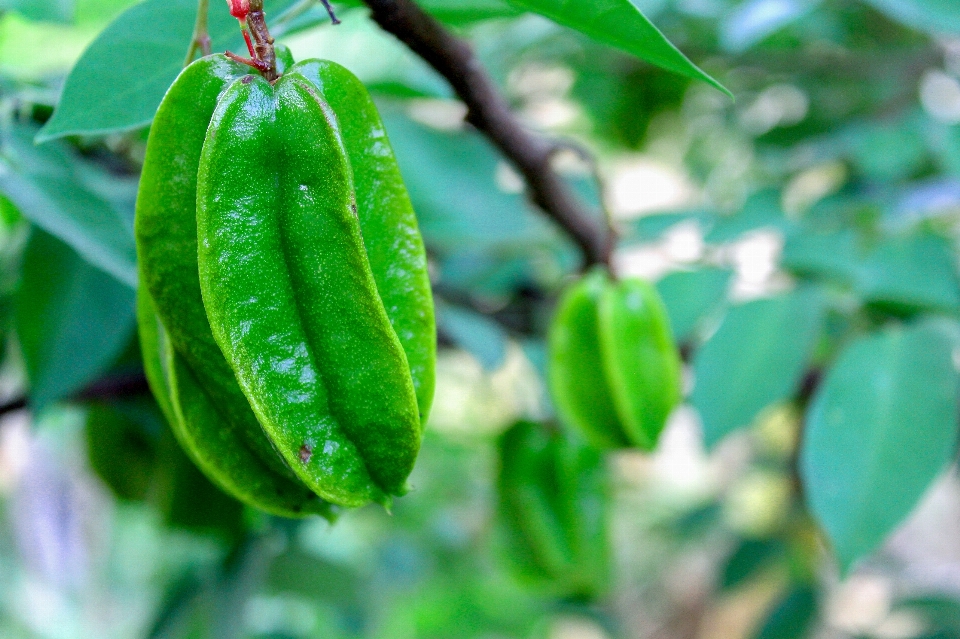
[{"xmin": 135, "ymin": 55, "xmax": 296, "ymax": 481}]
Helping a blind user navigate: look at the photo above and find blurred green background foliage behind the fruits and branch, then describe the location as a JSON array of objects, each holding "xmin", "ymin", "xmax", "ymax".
[{"xmin": 0, "ymin": 0, "xmax": 960, "ymax": 639}]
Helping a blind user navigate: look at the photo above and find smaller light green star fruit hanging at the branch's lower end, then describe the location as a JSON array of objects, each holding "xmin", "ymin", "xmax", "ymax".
[{"xmin": 549, "ymin": 270, "xmax": 681, "ymax": 450}]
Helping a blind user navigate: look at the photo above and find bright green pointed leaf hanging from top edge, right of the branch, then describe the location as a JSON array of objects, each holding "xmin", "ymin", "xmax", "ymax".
[{"xmin": 509, "ymin": 0, "xmax": 733, "ymax": 97}]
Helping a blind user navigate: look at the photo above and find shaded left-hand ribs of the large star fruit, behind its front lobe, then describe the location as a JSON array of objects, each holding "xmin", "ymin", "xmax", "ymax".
[{"xmin": 135, "ymin": 56, "xmax": 329, "ymax": 516}]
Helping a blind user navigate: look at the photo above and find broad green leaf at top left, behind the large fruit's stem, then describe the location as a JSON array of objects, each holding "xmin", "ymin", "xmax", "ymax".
[{"xmin": 37, "ymin": 0, "xmax": 290, "ymax": 143}]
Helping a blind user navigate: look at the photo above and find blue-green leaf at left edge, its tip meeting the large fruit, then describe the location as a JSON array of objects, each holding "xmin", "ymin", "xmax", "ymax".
[{"xmin": 0, "ymin": 127, "xmax": 137, "ymax": 287}]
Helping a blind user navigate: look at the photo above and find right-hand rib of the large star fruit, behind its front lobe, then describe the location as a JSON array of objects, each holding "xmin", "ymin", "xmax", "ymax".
[{"xmin": 289, "ymin": 60, "xmax": 437, "ymax": 426}]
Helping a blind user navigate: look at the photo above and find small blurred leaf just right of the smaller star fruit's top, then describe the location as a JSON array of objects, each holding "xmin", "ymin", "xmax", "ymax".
[{"xmin": 657, "ymin": 268, "xmax": 731, "ymax": 342}]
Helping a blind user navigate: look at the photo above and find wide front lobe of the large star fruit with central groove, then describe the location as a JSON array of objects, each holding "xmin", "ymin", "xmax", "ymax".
[{"xmin": 197, "ymin": 74, "xmax": 421, "ymax": 506}]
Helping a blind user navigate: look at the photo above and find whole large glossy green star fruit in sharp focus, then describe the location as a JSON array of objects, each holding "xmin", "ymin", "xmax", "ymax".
[{"xmin": 136, "ymin": 51, "xmax": 436, "ymax": 516}]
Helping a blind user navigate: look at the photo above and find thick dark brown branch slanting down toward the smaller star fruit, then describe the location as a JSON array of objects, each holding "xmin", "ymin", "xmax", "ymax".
[{"xmin": 364, "ymin": 0, "xmax": 614, "ymax": 266}]
